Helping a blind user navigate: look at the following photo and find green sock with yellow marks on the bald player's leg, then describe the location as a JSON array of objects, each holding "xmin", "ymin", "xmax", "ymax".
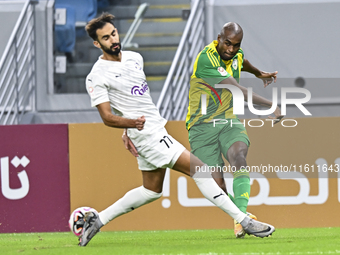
[{"xmin": 233, "ymin": 169, "xmax": 250, "ymax": 213}]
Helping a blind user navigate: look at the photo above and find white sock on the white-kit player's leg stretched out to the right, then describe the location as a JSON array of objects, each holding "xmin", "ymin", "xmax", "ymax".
[{"xmin": 192, "ymin": 165, "xmax": 246, "ymax": 222}]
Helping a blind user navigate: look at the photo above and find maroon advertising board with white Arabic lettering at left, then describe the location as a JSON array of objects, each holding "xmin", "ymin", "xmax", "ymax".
[{"xmin": 0, "ymin": 125, "xmax": 70, "ymax": 233}]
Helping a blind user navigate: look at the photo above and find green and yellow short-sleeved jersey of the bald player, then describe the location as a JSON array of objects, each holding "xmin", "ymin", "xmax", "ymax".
[{"xmin": 186, "ymin": 41, "xmax": 243, "ymax": 130}]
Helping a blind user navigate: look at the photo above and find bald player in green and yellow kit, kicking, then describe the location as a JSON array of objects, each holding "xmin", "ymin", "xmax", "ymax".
[{"xmin": 186, "ymin": 22, "xmax": 282, "ymax": 238}]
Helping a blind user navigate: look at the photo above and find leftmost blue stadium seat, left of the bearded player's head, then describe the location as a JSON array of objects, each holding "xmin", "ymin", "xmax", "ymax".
[{"xmin": 54, "ymin": 5, "xmax": 76, "ymax": 53}]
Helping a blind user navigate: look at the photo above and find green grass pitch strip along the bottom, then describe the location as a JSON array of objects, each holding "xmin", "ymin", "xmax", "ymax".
[{"xmin": 0, "ymin": 228, "xmax": 340, "ymax": 255}]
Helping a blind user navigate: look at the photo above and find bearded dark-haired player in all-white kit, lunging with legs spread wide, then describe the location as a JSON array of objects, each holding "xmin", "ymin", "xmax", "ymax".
[{"xmin": 79, "ymin": 13, "xmax": 275, "ymax": 246}]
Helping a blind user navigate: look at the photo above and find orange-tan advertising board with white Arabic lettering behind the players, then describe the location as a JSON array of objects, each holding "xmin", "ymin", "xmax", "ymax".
[{"xmin": 69, "ymin": 117, "xmax": 340, "ymax": 231}]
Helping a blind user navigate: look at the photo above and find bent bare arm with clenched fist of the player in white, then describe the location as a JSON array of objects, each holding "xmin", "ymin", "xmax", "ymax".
[{"xmin": 97, "ymin": 102, "xmax": 145, "ymax": 130}]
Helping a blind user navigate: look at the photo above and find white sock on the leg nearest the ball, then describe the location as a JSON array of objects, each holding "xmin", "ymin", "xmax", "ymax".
[{"xmin": 99, "ymin": 186, "xmax": 162, "ymax": 225}]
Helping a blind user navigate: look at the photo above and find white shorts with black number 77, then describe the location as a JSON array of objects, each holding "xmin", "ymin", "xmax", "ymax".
[{"xmin": 137, "ymin": 128, "xmax": 185, "ymax": 171}]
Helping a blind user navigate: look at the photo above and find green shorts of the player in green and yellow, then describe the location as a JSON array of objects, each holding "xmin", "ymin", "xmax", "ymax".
[{"xmin": 189, "ymin": 119, "xmax": 250, "ymax": 167}]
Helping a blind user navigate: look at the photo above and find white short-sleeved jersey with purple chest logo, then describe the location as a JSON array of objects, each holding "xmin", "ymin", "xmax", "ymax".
[{"xmin": 86, "ymin": 51, "xmax": 166, "ymax": 147}]
